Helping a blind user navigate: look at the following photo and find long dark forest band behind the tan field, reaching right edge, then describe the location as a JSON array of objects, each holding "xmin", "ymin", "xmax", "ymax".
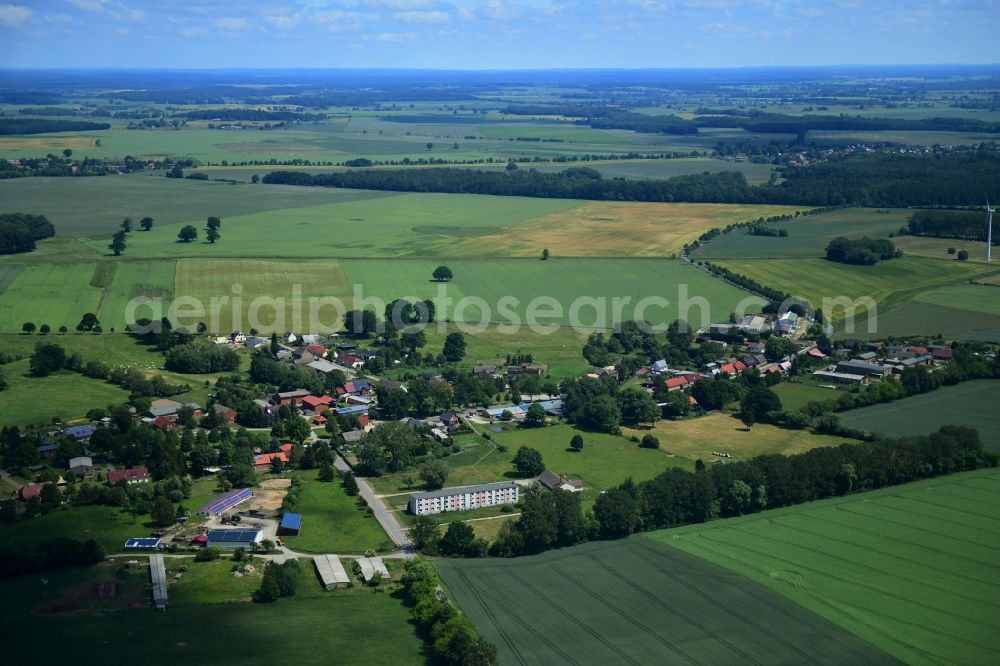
[{"xmin": 263, "ymin": 150, "xmax": 1000, "ymax": 207}]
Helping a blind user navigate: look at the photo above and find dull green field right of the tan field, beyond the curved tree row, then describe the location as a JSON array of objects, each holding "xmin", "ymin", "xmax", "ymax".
[{"xmin": 692, "ymin": 208, "xmax": 910, "ymax": 260}]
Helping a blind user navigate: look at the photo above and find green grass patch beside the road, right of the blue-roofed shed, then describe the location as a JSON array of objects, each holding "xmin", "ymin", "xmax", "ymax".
[{"xmin": 282, "ymin": 472, "xmax": 391, "ymax": 553}]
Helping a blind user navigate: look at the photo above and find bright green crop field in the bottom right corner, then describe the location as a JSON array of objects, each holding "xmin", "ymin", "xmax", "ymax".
[{"xmin": 648, "ymin": 469, "xmax": 1000, "ymax": 664}]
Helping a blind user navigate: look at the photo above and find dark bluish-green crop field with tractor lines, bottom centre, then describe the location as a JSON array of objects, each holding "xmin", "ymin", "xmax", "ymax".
[{"xmin": 435, "ymin": 538, "xmax": 892, "ymax": 666}]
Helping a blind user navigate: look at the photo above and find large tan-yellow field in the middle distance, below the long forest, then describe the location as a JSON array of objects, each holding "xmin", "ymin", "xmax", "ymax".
[{"xmin": 458, "ymin": 200, "xmax": 797, "ymax": 257}]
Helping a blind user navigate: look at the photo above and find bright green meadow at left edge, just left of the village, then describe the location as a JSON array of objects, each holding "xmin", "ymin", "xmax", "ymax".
[{"xmin": 0, "ymin": 358, "xmax": 129, "ymax": 426}]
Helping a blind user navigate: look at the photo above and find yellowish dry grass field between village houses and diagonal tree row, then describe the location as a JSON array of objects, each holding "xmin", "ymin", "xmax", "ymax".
[{"xmin": 620, "ymin": 413, "xmax": 844, "ymax": 464}]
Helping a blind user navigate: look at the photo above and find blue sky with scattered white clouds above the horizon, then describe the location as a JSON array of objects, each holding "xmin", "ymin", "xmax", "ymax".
[{"xmin": 0, "ymin": 0, "xmax": 1000, "ymax": 69}]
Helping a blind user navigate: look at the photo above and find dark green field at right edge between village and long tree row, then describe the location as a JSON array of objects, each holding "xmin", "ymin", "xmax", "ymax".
[{"xmin": 841, "ymin": 379, "xmax": 1000, "ymax": 451}]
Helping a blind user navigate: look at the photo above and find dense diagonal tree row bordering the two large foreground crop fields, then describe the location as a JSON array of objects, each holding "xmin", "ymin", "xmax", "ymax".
[{"xmin": 489, "ymin": 426, "xmax": 1000, "ymax": 557}]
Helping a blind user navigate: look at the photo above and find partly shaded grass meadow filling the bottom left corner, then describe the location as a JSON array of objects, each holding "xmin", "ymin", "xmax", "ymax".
[{"xmin": 0, "ymin": 559, "xmax": 429, "ymax": 666}]
